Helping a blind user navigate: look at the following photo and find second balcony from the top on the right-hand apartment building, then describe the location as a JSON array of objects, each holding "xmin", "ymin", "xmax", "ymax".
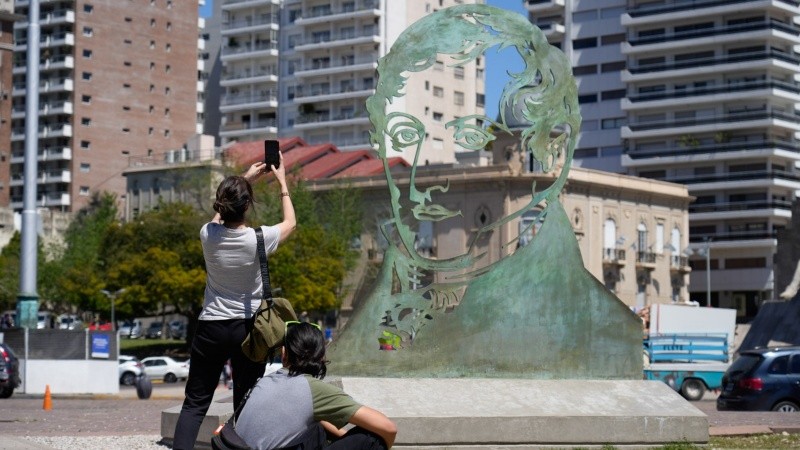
[{"xmin": 623, "ymin": 19, "xmax": 800, "ymax": 49}]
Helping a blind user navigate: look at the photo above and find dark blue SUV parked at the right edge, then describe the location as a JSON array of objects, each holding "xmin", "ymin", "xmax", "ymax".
[{"xmin": 717, "ymin": 347, "xmax": 800, "ymax": 412}]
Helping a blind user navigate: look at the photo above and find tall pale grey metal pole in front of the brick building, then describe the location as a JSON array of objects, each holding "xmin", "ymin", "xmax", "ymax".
[{"xmin": 17, "ymin": 0, "xmax": 39, "ymax": 329}]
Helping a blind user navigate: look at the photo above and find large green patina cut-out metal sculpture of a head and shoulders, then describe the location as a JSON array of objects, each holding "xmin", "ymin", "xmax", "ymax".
[{"xmin": 329, "ymin": 5, "xmax": 642, "ymax": 379}]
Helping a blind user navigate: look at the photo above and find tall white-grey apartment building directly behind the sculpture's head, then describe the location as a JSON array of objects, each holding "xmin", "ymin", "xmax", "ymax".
[{"xmin": 220, "ymin": 0, "xmax": 484, "ymax": 163}]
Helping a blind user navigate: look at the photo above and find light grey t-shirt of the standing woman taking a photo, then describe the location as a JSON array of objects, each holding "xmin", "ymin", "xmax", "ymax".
[{"xmin": 200, "ymin": 222, "xmax": 281, "ymax": 320}]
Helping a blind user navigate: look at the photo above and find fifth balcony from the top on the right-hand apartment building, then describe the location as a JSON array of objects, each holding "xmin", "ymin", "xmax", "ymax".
[{"xmin": 620, "ymin": 110, "xmax": 800, "ymax": 139}]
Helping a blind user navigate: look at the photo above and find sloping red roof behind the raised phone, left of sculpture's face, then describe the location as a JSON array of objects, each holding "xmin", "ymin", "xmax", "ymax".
[{"xmin": 225, "ymin": 137, "xmax": 409, "ymax": 180}]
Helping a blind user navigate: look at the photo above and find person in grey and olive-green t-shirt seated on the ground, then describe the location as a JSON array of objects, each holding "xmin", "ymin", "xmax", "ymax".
[{"xmin": 236, "ymin": 322, "xmax": 397, "ymax": 450}]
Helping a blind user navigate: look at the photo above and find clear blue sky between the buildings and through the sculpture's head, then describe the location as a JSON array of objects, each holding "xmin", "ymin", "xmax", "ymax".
[{"xmin": 200, "ymin": 0, "xmax": 528, "ymax": 118}]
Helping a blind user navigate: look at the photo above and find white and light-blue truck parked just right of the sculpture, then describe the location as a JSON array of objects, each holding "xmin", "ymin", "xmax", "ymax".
[{"xmin": 644, "ymin": 304, "xmax": 736, "ymax": 401}]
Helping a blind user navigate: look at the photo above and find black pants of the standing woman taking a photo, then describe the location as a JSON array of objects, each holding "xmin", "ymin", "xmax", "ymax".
[{"xmin": 172, "ymin": 319, "xmax": 266, "ymax": 450}]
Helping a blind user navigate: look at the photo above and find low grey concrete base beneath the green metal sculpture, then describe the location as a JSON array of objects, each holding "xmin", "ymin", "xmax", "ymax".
[{"xmin": 161, "ymin": 377, "xmax": 708, "ymax": 450}]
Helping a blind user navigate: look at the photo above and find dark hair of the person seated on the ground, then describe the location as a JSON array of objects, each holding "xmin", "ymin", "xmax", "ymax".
[{"xmin": 283, "ymin": 323, "xmax": 328, "ymax": 380}]
